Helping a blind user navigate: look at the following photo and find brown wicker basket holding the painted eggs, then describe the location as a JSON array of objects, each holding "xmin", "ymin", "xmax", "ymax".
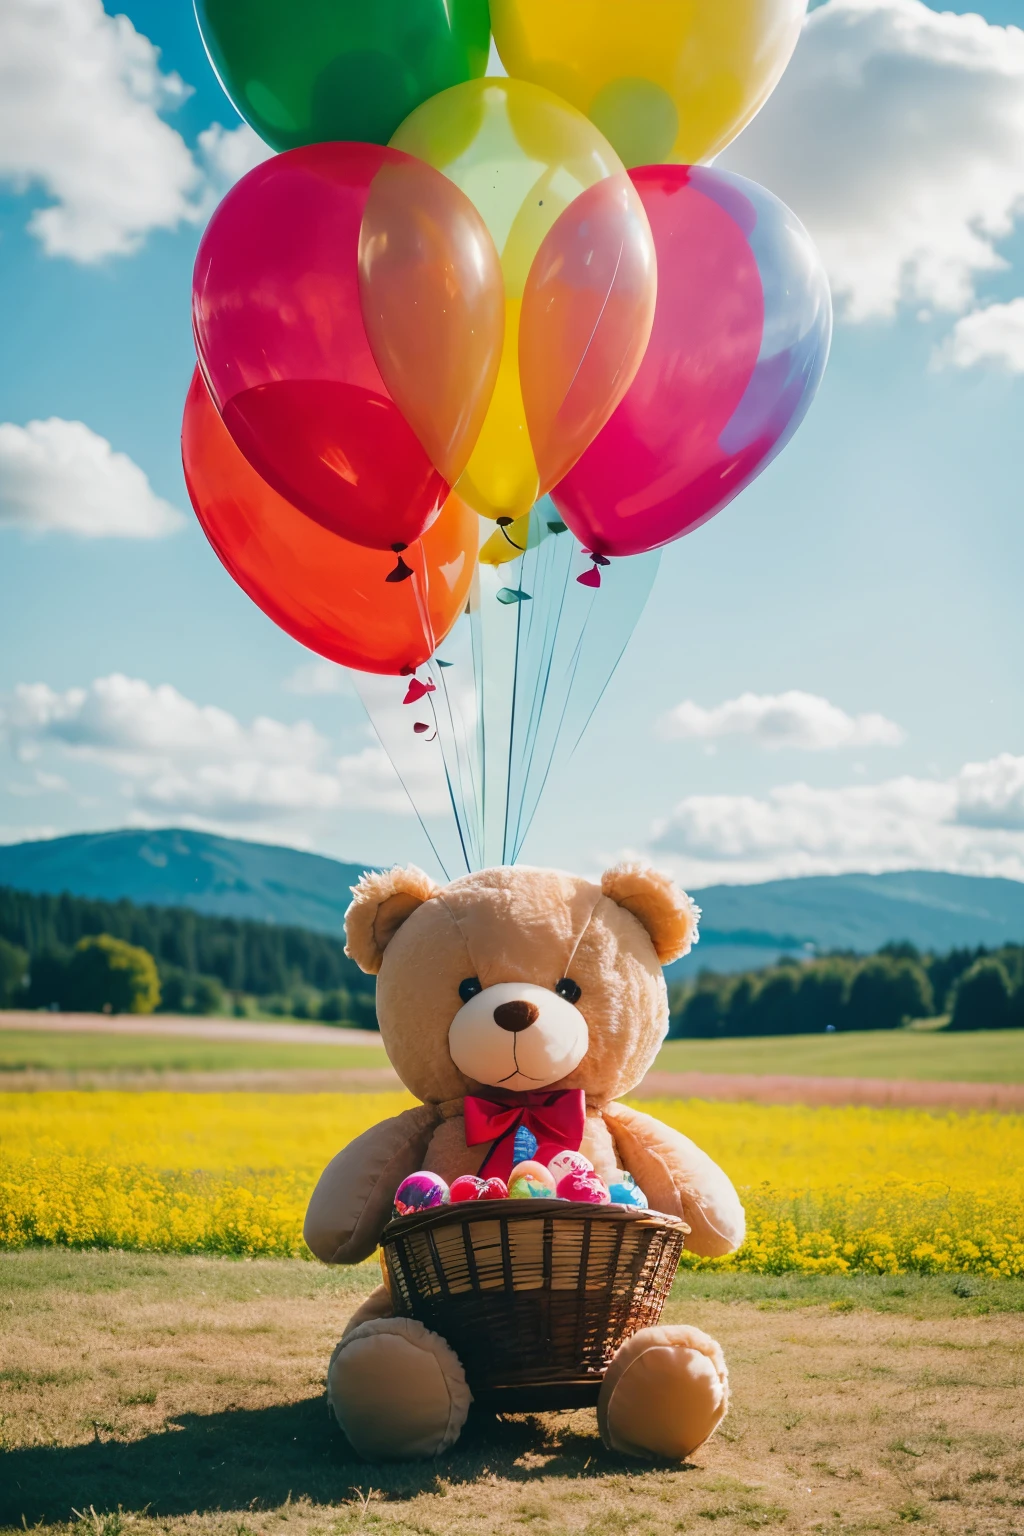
[{"xmin": 381, "ymin": 1200, "xmax": 689, "ymax": 1413}]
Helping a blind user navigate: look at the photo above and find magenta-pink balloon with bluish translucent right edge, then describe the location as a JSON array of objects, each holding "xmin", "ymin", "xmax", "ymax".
[{"xmin": 551, "ymin": 166, "xmax": 832, "ymax": 559}]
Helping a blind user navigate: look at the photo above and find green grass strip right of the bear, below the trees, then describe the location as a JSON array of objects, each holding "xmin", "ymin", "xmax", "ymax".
[{"xmin": 656, "ymin": 1029, "xmax": 1024, "ymax": 1083}]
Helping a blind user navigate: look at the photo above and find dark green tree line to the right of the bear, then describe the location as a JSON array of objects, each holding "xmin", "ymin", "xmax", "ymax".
[{"xmin": 669, "ymin": 927, "xmax": 1024, "ymax": 1040}]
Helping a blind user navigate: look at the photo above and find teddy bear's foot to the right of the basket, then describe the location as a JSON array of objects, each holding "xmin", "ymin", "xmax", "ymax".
[{"xmin": 597, "ymin": 1327, "xmax": 729, "ymax": 1461}]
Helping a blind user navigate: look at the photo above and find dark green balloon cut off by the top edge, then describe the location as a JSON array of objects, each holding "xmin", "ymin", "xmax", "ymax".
[{"xmin": 195, "ymin": 0, "xmax": 491, "ymax": 149}]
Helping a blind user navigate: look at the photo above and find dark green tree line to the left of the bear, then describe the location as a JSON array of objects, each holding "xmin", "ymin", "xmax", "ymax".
[{"xmin": 0, "ymin": 886, "xmax": 376, "ymax": 1029}]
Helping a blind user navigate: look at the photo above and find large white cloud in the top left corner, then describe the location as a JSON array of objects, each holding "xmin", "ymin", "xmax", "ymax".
[{"xmin": 0, "ymin": 0, "xmax": 270, "ymax": 263}]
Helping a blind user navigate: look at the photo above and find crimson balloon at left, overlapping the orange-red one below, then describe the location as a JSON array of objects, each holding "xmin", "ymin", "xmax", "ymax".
[{"xmin": 192, "ymin": 144, "xmax": 500, "ymax": 548}]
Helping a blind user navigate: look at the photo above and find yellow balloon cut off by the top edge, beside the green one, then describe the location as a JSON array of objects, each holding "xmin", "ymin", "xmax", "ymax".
[{"xmin": 491, "ymin": 0, "xmax": 808, "ymax": 166}]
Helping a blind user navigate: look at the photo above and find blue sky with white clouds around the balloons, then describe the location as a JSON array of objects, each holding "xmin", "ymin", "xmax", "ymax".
[{"xmin": 0, "ymin": 0, "xmax": 1024, "ymax": 885}]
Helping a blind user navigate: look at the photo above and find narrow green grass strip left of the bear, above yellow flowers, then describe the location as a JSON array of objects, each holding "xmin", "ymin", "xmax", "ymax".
[{"xmin": 0, "ymin": 1029, "xmax": 387, "ymax": 1072}]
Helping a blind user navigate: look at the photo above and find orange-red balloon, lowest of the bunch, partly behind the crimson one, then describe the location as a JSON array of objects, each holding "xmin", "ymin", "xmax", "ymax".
[{"xmin": 181, "ymin": 369, "xmax": 479, "ymax": 676}]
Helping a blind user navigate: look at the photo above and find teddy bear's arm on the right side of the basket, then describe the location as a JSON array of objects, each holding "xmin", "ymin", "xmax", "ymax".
[{"xmin": 605, "ymin": 1104, "xmax": 745, "ymax": 1258}]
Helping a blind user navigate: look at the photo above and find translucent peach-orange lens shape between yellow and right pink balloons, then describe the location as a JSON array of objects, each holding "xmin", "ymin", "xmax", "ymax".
[{"xmin": 519, "ymin": 170, "xmax": 657, "ymax": 496}]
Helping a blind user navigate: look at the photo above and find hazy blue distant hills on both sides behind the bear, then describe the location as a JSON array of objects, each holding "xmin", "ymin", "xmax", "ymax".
[{"xmin": 0, "ymin": 831, "xmax": 1024, "ymax": 975}]
